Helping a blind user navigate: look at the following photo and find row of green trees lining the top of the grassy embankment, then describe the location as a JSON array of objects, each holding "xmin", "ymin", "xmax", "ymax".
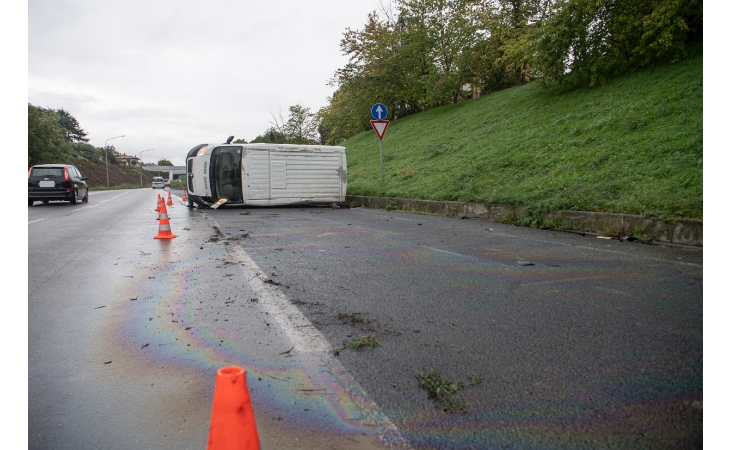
[{"xmin": 317, "ymin": 0, "xmax": 702, "ymax": 144}]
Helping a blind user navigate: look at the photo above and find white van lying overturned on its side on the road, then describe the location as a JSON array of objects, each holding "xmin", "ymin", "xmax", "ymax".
[{"xmin": 186, "ymin": 136, "xmax": 347, "ymax": 207}]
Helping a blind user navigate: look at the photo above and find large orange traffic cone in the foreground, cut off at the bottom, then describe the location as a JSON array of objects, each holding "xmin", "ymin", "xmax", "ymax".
[{"xmin": 208, "ymin": 366, "xmax": 259, "ymax": 450}]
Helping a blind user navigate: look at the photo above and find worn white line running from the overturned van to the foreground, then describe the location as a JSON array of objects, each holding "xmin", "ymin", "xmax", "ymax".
[{"xmin": 199, "ymin": 211, "xmax": 408, "ymax": 448}]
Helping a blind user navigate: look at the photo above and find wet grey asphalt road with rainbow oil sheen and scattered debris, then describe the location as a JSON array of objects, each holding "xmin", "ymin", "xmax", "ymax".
[{"xmin": 28, "ymin": 190, "xmax": 703, "ymax": 449}]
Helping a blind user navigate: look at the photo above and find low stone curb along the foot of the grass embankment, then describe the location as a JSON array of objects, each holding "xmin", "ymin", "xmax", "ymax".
[{"xmin": 346, "ymin": 195, "xmax": 702, "ymax": 247}]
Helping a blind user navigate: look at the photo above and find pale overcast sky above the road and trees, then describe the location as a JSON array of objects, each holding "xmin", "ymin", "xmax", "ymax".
[{"xmin": 28, "ymin": 0, "xmax": 380, "ymax": 165}]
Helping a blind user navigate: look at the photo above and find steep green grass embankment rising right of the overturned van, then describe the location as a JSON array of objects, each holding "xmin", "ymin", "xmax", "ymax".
[{"xmin": 342, "ymin": 47, "xmax": 702, "ymax": 221}]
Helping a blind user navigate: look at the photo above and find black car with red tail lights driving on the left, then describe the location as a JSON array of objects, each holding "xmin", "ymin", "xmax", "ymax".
[{"xmin": 28, "ymin": 164, "xmax": 89, "ymax": 206}]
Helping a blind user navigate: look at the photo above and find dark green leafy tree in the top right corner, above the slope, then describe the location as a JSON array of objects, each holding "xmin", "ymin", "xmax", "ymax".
[{"xmin": 534, "ymin": 0, "xmax": 702, "ymax": 85}]
